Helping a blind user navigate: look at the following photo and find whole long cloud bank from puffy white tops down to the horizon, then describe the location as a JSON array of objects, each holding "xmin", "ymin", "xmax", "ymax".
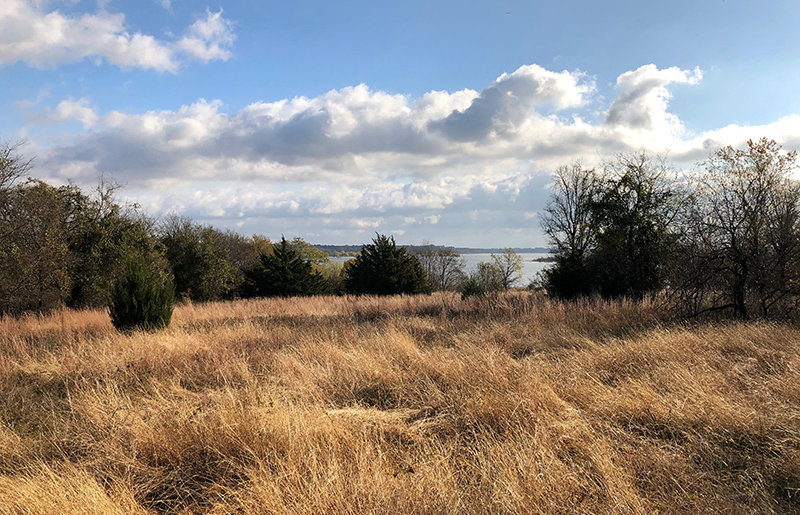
[{"xmin": 28, "ymin": 62, "xmax": 800, "ymax": 244}]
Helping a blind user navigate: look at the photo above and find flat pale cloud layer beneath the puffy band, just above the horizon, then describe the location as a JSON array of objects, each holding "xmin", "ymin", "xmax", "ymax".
[{"xmin": 126, "ymin": 173, "xmax": 549, "ymax": 245}]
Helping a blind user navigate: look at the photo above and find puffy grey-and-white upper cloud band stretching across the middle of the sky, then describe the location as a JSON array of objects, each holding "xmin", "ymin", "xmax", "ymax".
[{"xmin": 42, "ymin": 65, "xmax": 798, "ymax": 186}]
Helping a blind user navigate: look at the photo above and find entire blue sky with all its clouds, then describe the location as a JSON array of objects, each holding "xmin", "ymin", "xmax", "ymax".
[{"xmin": 0, "ymin": 0, "xmax": 800, "ymax": 247}]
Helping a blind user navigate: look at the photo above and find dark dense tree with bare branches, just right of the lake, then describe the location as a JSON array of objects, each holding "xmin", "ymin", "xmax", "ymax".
[{"xmin": 542, "ymin": 154, "xmax": 685, "ymax": 298}]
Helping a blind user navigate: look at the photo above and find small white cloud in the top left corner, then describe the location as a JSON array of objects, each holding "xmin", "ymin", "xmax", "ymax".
[{"xmin": 0, "ymin": 0, "xmax": 236, "ymax": 72}]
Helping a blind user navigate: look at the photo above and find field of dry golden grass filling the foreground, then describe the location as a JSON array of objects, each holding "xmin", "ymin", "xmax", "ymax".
[{"xmin": 0, "ymin": 294, "xmax": 800, "ymax": 515}]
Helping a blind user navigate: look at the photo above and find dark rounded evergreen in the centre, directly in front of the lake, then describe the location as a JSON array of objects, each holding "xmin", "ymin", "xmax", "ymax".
[{"xmin": 345, "ymin": 234, "xmax": 431, "ymax": 295}]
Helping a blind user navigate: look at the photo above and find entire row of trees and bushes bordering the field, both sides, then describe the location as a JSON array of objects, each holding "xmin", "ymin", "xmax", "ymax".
[{"xmin": 0, "ymin": 139, "xmax": 800, "ymax": 325}]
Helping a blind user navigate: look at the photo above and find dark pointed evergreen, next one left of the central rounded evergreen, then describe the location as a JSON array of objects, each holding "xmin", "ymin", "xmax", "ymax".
[{"xmin": 244, "ymin": 237, "xmax": 330, "ymax": 297}]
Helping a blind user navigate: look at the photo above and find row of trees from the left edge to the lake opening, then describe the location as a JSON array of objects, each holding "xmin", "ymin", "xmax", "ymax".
[{"xmin": 0, "ymin": 139, "xmax": 521, "ymax": 320}]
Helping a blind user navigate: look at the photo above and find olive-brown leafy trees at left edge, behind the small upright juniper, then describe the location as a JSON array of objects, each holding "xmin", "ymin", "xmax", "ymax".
[{"xmin": 0, "ymin": 168, "xmax": 164, "ymax": 313}]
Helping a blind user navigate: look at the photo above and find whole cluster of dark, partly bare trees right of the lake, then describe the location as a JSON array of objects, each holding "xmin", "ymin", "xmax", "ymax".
[{"xmin": 541, "ymin": 139, "xmax": 800, "ymax": 319}]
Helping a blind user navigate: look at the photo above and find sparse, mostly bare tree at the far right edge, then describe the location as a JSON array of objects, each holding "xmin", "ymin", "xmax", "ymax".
[{"xmin": 682, "ymin": 139, "xmax": 800, "ymax": 318}]
